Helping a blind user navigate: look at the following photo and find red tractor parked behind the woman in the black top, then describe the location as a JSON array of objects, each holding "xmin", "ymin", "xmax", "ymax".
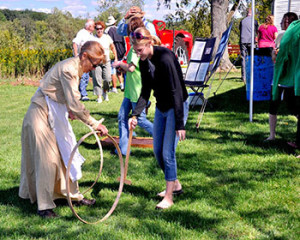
[{"xmin": 126, "ymin": 20, "xmax": 193, "ymax": 66}]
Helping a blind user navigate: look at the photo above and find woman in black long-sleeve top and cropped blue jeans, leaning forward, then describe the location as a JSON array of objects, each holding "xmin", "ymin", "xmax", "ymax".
[{"xmin": 129, "ymin": 28, "xmax": 188, "ymax": 209}]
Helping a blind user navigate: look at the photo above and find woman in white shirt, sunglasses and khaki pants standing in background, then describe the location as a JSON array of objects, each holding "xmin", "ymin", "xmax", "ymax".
[{"xmin": 92, "ymin": 21, "xmax": 118, "ymax": 103}]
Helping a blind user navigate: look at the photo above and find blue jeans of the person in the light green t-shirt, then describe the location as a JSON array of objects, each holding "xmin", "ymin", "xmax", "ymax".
[{"xmin": 118, "ymin": 98, "xmax": 153, "ymax": 155}]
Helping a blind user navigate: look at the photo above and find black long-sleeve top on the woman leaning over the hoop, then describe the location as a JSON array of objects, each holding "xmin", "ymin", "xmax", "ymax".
[{"xmin": 132, "ymin": 46, "xmax": 188, "ymax": 130}]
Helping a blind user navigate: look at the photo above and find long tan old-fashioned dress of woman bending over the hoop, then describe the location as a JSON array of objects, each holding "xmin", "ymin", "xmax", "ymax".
[{"xmin": 19, "ymin": 57, "xmax": 99, "ymax": 210}]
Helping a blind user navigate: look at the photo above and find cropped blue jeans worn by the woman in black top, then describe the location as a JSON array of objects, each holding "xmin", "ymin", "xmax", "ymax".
[{"xmin": 153, "ymin": 101, "xmax": 189, "ymax": 181}]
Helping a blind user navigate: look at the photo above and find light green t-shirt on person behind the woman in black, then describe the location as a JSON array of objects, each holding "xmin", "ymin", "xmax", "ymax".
[{"xmin": 124, "ymin": 48, "xmax": 142, "ymax": 102}]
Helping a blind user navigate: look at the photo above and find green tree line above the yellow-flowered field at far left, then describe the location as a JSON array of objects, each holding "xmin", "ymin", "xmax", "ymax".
[{"xmin": 0, "ymin": 8, "xmax": 85, "ymax": 50}]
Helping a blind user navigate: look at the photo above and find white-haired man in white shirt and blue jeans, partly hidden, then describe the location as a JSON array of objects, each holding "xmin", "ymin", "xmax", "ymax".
[{"xmin": 72, "ymin": 19, "xmax": 95, "ymax": 101}]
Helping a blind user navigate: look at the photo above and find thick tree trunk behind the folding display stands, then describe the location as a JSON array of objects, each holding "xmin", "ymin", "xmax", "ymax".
[{"xmin": 211, "ymin": 0, "xmax": 232, "ymax": 70}]
